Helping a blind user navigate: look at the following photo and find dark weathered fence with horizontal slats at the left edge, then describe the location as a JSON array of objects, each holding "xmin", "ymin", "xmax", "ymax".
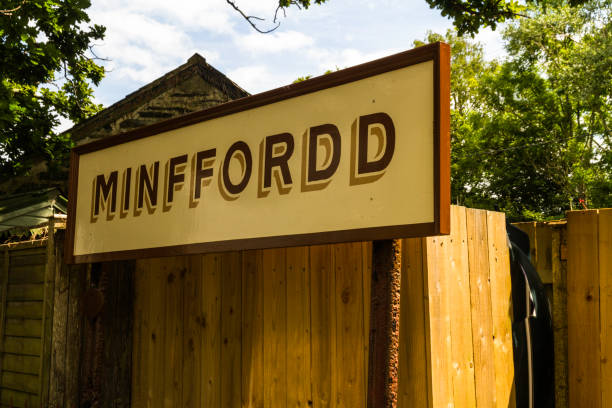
[{"xmin": 0, "ymin": 239, "xmax": 53, "ymax": 407}]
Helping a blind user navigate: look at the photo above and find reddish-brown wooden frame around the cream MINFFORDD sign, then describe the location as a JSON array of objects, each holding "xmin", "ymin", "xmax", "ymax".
[{"xmin": 65, "ymin": 43, "xmax": 450, "ymax": 263}]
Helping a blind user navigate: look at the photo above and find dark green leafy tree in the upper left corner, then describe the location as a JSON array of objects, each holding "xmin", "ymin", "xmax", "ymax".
[{"xmin": 0, "ymin": 0, "xmax": 104, "ymax": 181}]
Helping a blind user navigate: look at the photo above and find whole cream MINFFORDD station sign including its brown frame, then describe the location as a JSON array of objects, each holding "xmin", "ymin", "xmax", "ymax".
[{"xmin": 68, "ymin": 44, "xmax": 449, "ymax": 262}]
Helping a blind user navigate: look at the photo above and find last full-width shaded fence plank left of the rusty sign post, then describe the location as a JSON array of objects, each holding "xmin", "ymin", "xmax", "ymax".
[{"xmin": 333, "ymin": 243, "xmax": 366, "ymax": 408}]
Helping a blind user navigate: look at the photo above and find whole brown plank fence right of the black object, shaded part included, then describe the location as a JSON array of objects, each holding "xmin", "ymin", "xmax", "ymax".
[{"xmin": 518, "ymin": 209, "xmax": 612, "ymax": 408}]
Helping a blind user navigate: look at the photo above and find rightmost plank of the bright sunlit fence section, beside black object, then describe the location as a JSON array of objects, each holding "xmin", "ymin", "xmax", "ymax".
[{"xmin": 487, "ymin": 211, "xmax": 516, "ymax": 408}]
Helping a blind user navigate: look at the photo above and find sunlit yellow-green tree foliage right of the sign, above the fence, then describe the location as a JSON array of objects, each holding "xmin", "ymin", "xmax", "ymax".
[{"xmin": 424, "ymin": 1, "xmax": 612, "ymax": 219}]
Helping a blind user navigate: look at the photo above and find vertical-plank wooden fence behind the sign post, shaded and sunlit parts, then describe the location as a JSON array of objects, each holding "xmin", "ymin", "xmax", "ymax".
[{"xmin": 132, "ymin": 207, "xmax": 514, "ymax": 408}]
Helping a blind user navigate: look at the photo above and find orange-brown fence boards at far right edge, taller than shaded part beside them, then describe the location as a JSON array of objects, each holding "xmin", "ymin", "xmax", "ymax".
[{"xmin": 567, "ymin": 209, "xmax": 612, "ymax": 408}]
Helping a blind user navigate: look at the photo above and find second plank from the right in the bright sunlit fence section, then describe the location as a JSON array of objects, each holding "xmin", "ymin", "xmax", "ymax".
[{"xmin": 466, "ymin": 209, "xmax": 495, "ymax": 408}]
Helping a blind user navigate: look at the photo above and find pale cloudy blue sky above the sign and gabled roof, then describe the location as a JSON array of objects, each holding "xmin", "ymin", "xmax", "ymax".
[{"xmin": 88, "ymin": 0, "xmax": 503, "ymax": 106}]
